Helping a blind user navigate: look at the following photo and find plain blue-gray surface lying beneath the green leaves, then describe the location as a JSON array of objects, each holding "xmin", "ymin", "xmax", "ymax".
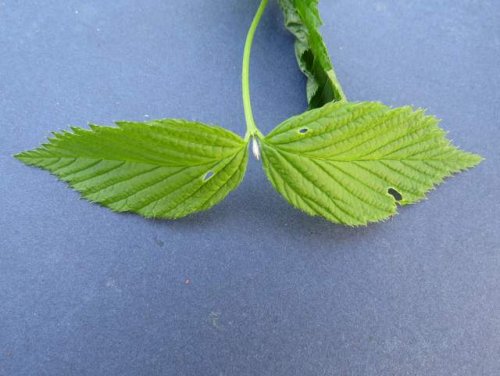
[{"xmin": 0, "ymin": 0, "xmax": 500, "ymax": 376}]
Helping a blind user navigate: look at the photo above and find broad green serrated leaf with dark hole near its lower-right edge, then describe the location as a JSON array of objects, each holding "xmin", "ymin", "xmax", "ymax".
[{"xmin": 261, "ymin": 102, "xmax": 481, "ymax": 226}]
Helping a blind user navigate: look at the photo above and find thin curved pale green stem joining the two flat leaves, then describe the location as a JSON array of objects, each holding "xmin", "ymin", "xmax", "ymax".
[{"xmin": 241, "ymin": 0, "xmax": 268, "ymax": 140}]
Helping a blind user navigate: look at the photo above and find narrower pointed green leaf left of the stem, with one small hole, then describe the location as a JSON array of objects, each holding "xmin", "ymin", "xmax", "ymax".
[{"xmin": 16, "ymin": 120, "xmax": 248, "ymax": 218}]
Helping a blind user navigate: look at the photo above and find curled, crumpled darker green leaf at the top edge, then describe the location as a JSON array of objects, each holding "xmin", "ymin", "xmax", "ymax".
[{"xmin": 279, "ymin": 0, "xmax": 345, "ymax": 109}]
